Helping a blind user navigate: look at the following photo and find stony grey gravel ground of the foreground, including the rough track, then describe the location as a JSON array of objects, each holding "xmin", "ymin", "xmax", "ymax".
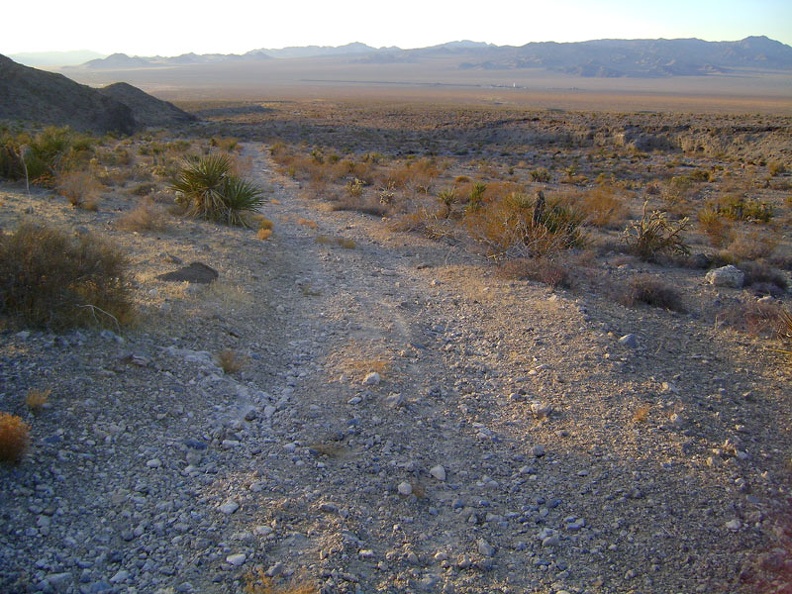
[{"xmin": 0, "ymin": 145, "xmax": 792, "ymax": 594}]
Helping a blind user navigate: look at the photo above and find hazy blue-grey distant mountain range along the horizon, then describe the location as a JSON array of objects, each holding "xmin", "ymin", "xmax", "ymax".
[{"xmin": 69, "ymin": 36, "xmax": 792, "ymax": 77}]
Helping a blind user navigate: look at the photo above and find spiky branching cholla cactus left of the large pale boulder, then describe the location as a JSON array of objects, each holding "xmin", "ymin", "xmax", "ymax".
[{"xmin": 622, "ymin": 203, "xmax": 690, "ymax": 262}]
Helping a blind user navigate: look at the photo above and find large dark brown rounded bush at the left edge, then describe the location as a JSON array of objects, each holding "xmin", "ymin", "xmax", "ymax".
[{"xmin": 0, "ymin": 223, "xmax": 133, "ymax": 330}]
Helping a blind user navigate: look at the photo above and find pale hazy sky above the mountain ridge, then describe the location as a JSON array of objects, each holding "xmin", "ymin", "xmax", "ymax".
[{"xmin": 0, "ymin": 0, "xmax": 792, "ymax": 56}]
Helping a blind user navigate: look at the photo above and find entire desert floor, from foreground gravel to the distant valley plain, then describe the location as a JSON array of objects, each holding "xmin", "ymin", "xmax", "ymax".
[{"xmin": 0, "ymin": 72, "xmax": 792, "ymax": 594}]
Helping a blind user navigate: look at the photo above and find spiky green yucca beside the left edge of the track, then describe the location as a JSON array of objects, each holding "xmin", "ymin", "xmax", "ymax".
[{"xmin": 171, "ymin": 153, "xmax": 264, "ymax": 226}]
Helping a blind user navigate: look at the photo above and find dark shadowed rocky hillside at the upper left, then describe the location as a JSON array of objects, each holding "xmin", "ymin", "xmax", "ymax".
[{"xmin": 0, "ymin": 55, "xmax": 194, "ymax": 134}]
